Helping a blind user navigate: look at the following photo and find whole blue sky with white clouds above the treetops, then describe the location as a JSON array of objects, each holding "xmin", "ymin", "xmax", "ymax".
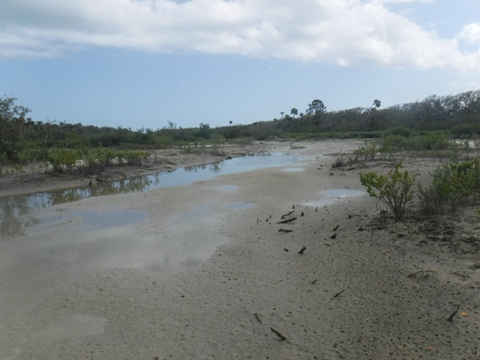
[{"xmin": 0, "ymin": 0, "xmax": 480, "ymax": 130}]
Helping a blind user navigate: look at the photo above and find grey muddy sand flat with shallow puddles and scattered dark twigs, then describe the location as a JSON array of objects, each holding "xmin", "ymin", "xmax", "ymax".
[{"xmin": 0, "ymin": 140, "xmax": 480, "ymax": 360}]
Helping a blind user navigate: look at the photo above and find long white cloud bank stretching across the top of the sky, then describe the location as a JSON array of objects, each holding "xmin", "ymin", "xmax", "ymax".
[{"xmin": 0, "ymin": 0, "xmax": 480, "ymax": 69}]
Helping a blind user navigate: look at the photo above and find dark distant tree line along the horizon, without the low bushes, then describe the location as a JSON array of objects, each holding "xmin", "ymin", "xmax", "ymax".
[{"xmin": 0, "ymin": 90, "xmax": 480, "ymax": 163}]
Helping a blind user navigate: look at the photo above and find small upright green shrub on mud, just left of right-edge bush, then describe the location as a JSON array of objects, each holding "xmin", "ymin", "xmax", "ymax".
[{"xmin": 360, "ymin": 162, "xmax": 416, "ymax": 220}]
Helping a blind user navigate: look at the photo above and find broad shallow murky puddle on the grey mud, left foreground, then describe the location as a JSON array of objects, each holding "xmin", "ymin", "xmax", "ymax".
[{"xmin": 0, "ymin": 204, "xmax": 229, "ymax": 318}]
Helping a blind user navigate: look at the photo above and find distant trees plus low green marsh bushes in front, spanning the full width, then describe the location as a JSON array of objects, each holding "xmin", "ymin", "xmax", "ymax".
[{"xmin": 0, "ymin": 90, "xmax": 480, "ymax": 179}]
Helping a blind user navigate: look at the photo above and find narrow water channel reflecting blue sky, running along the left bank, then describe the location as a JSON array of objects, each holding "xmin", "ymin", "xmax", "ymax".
[{"xmin": 0, "ymin": 153, "xmax": 305, "ymax": 240}]
